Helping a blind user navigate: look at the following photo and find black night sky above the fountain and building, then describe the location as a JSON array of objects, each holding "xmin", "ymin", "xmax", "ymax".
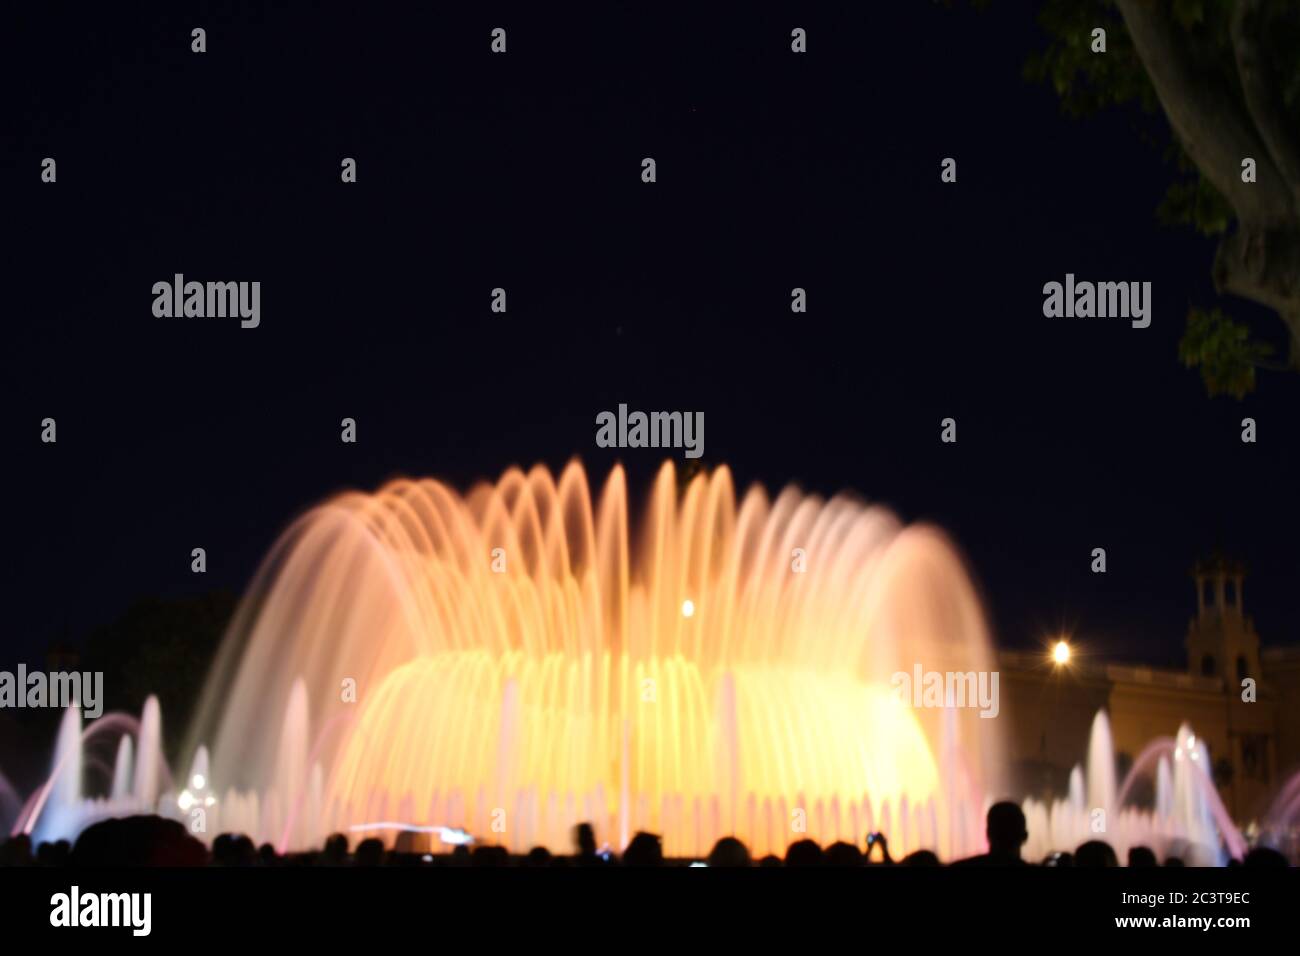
[{"xmin": 0, "ymin": 1, "xmax": 1300, "ymax": 667}]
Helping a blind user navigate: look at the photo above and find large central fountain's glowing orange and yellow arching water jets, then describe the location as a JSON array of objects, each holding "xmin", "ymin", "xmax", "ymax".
[{"xmin": 183, "ymin": 463, "xmax": 1001, "ymax": 857}]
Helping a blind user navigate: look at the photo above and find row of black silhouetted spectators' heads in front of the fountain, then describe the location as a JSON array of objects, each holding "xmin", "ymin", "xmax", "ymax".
[{"xmin": 0, "ymin": 803, "xmax": 1288, "ymax": 868}]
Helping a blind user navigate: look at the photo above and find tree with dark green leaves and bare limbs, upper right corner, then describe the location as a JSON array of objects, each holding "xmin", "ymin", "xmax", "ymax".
[{"xmin": 982, "ymin": 0, "xmax": 1300, "ymax": 398}]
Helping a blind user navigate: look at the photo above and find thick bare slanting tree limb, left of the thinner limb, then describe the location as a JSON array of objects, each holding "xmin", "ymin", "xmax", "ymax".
[{"xmin": 1115, "ymin": 0, "xmax": 1292, "ymax": 225}]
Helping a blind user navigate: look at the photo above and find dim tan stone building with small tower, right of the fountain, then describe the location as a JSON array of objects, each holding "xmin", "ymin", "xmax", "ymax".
[{"xmin": 1000, "ymin": 561, "xmax": 1300, "ymax": 826}]
